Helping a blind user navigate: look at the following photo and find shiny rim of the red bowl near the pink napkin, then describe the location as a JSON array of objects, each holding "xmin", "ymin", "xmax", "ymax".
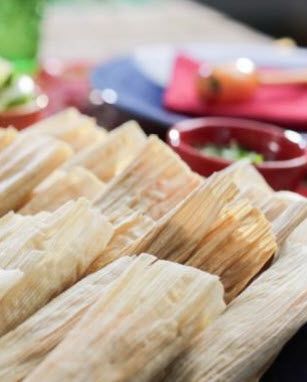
[{"xmin": 167, "ymin": 117, "xmax": 307, "ymax": 170}]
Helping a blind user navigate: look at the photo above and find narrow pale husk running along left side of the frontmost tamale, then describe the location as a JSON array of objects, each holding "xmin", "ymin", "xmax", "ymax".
[{"xmin": 0, "ymin": 256, "xmax": 133, "ymax": 382}]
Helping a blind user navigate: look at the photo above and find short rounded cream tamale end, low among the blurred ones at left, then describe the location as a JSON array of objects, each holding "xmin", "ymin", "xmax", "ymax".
[{"xmin": 19, "ymin": 167, "xmax": 105, "ymax": 215}]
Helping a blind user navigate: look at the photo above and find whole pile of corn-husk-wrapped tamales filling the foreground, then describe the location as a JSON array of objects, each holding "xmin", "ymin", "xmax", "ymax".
[{"xmin": 0, "ymin": 109, "xmax": 307, "ymax": 382}]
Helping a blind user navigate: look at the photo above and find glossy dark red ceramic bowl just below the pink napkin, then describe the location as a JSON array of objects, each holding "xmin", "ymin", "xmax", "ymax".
[{"xmin": 167, "ymin": 117, "xmax": 307, "ymax": 190}]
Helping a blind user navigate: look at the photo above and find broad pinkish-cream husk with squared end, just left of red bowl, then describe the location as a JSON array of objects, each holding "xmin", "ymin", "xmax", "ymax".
[{"xmin": 95, "ymin": 137, "xmax": 202, "ymax": 220}]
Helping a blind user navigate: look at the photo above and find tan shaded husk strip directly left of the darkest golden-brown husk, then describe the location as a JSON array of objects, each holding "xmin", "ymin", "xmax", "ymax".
[{"xmin": 136, "ymin": 174, "xmax": 237, "ymax": 263}]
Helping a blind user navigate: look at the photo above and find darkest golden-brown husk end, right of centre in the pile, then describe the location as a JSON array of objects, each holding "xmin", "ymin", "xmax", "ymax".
[{"xmin": 186, "ymin": 200, "xmax": 277, "ymax": 302}]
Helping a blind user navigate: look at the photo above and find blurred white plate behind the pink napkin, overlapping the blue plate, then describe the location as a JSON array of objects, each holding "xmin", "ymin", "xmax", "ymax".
[{"xmin": 133, "ymin": 43, "xmax": 307, "ymax": 87}]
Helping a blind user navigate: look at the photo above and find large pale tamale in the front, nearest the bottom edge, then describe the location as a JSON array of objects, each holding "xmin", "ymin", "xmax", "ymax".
[{"xmin": 25, "ymin": 255, "xmax": 225, "ymax": 382}]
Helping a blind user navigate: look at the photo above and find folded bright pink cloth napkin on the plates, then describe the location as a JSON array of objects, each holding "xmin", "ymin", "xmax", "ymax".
[{"xmin": 164, "ymin": 55, "xmax": 307, "ymax": 130}]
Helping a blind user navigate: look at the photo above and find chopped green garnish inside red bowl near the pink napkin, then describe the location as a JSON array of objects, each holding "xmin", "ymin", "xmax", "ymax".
[{"xmin": 200, "ymin": 141, "xmax": 264, "ymax": 165}]
